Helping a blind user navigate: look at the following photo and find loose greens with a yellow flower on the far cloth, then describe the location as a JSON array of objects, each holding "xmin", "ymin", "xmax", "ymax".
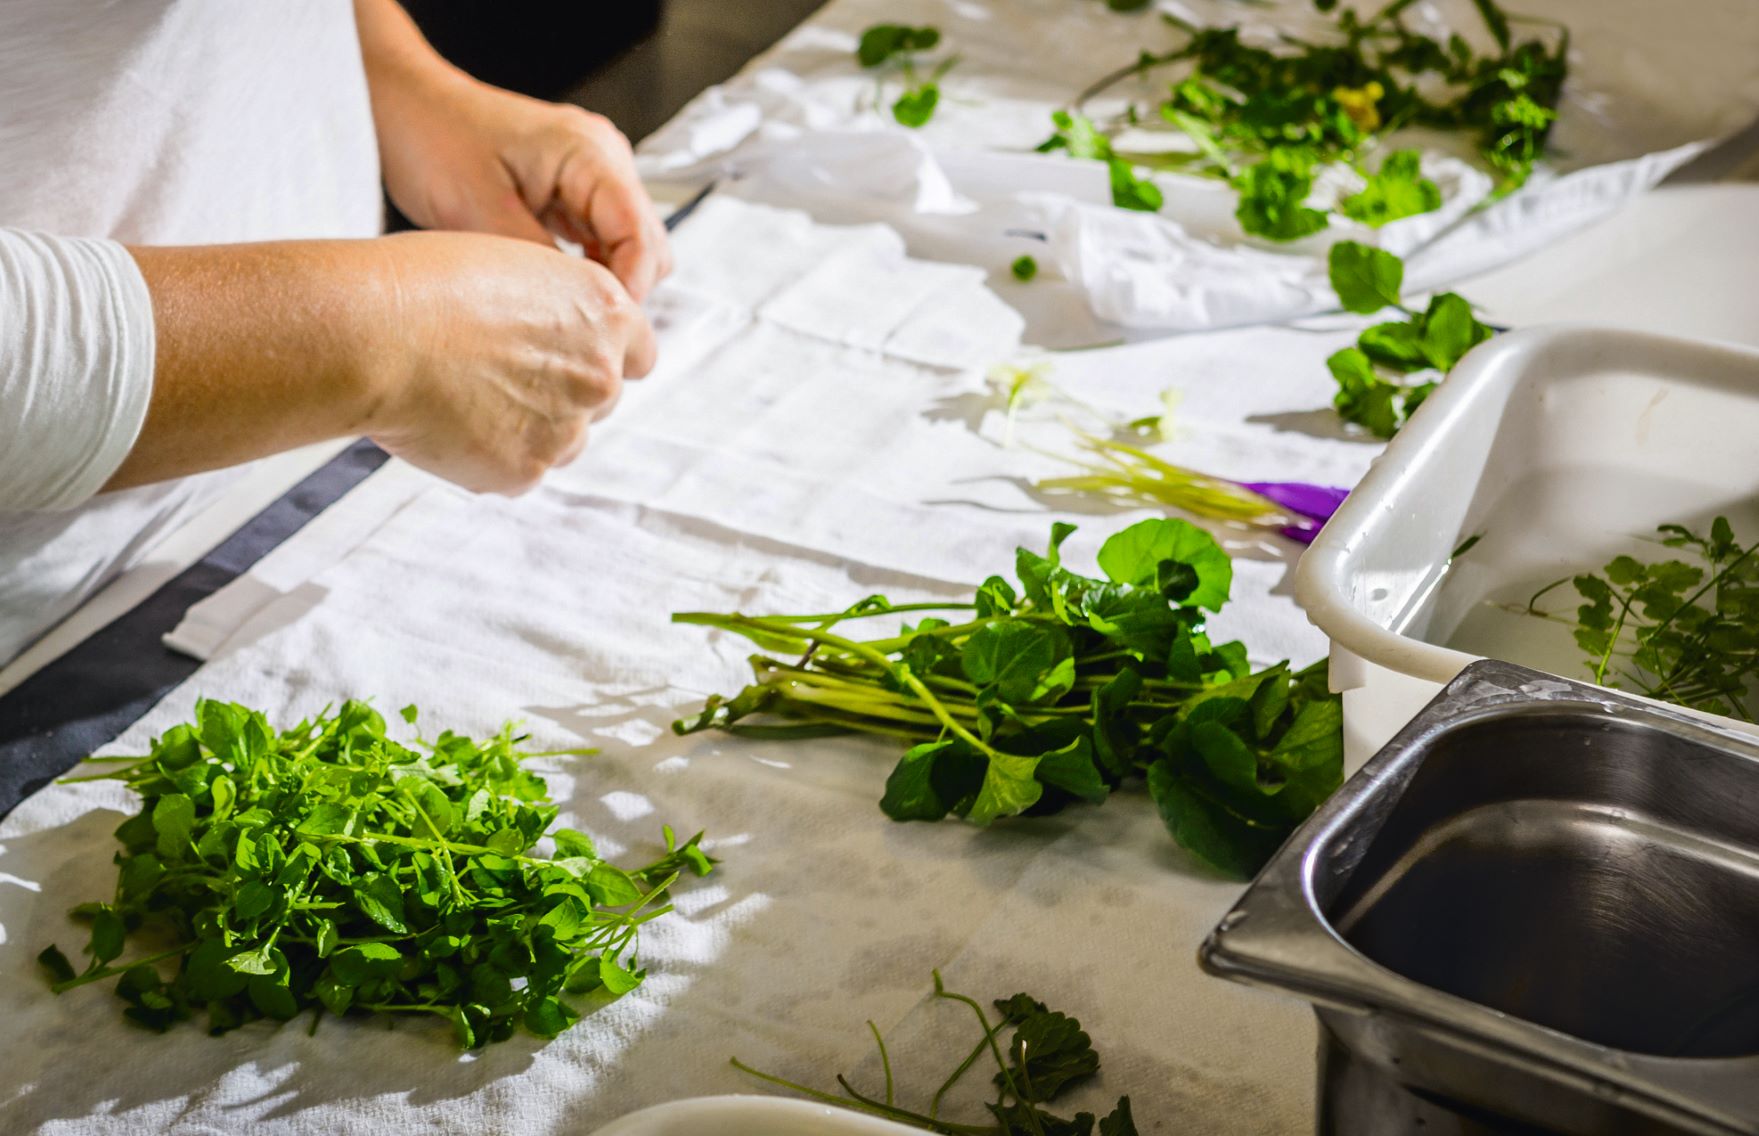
[{"xmin": 1041, "ymin": 0, "xmax": 1569, "ymax": 241}]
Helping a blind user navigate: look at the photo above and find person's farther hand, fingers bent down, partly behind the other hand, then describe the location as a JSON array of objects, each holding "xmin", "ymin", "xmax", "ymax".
[{"xmin": 371, "ymin": 48, "xmax": 672, "ymax": 301}]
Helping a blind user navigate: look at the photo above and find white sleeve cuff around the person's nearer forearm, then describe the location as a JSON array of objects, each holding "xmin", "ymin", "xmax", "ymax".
[{"xmin": 0, "ymin": 229, "xmax": 155, "ymax": 512}]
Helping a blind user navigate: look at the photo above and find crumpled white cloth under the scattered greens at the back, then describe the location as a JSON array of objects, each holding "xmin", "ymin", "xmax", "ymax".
[{"xmin": 640, "ymin": 0, "xmax": 1759, "ymax": 335}]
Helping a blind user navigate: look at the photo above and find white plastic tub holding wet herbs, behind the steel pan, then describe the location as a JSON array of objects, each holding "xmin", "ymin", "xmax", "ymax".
[{"xmin": 1296, "ymin": 325, "xmax": 1759, "ymax": 768}]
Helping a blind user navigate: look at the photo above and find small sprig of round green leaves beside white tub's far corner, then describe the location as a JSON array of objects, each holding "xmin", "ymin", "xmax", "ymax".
[{"xmin": 1326, "ymin": 241, "xmax": 1495, "ymax": 438}]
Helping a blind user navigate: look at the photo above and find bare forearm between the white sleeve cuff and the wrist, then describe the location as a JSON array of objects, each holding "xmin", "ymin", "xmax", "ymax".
[{"xmin": 106, "ymin": 241, "xmax": 399, "ymax": 489}]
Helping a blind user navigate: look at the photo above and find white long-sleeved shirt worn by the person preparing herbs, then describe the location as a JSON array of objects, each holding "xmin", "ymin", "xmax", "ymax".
[{"xmin": 0, "ymin": 0, "xmax": 382, "ymax": 663}]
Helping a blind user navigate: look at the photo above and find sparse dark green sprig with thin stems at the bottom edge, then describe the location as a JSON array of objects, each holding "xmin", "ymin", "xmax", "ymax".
[{"xmin": 734, "ymin": 971, "xmax": 1136, "ymax": 1136}]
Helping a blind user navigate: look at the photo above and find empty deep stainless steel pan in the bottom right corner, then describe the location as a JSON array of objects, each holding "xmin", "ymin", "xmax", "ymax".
[{"xmin": 1201, "ymin": 661, "xmax": 1759, "ymax": 1136}]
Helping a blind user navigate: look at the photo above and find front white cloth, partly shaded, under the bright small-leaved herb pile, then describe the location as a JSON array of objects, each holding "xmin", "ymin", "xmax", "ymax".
[{"xmin": 0, "ymin": 488, "xmax": 1312, "ymax": 1136}]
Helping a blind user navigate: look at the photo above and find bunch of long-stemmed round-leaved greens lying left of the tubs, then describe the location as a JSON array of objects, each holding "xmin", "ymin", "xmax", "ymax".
[{"xmin": 674, "ymin": 519, "xmax": 1342, "ymax": 876}]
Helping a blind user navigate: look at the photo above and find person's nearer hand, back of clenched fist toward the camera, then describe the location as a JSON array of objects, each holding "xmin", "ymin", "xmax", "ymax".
[{"xmin": 368, "ymin": 232, "xmax": 654, "ymax": 492}]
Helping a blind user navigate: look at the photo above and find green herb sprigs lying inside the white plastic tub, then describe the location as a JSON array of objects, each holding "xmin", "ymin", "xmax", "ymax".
[{"xmin": 1527, "ymin": 517, "xmax": 1759, "ymax": 721}]
